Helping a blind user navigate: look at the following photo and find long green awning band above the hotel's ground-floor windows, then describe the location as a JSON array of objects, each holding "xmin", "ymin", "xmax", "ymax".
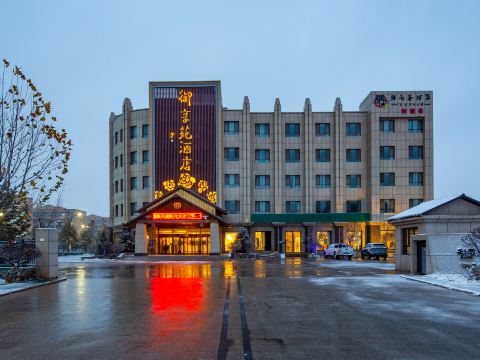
[{"xmin": 251, "ymin": 213, "xmax": 370, "ymax": 224}]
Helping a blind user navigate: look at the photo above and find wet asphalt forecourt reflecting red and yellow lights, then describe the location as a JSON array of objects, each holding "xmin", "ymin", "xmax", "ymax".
[{"xmin": 0, "ymin": 258, "xmax": 480, "ymax": 359}]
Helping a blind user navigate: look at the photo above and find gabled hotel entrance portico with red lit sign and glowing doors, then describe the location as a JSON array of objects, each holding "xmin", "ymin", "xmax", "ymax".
[{"xmin": 126, "ymin": 187, "xmax": 228, "ymax": 255}]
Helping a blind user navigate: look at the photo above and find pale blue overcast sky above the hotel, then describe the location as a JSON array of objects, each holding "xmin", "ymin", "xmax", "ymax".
[{"xmin": 0, "ymin": 0, "xmax": 480, "ymax": 216}]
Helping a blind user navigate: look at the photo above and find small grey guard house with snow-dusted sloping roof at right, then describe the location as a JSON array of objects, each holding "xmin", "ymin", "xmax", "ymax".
[{"xmin": 388, "ymin": 194, "xmax": 480, "ymax": 274}]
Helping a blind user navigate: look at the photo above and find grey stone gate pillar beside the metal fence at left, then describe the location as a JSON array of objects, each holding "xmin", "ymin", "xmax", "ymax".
[{"xmin": 35, "ymin": 229, "xmax": 58, "ymax": 279}]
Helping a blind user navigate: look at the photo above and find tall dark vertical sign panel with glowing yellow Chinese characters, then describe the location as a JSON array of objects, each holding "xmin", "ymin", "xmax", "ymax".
[{"xmin": 153, "ymin": 85, "xmax": 217, "ymax": 203}]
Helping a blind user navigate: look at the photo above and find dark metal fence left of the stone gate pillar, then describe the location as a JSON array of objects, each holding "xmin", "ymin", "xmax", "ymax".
[{"xmin": 0, "ymin": 240, "xmax": 37, "ymax": 268}]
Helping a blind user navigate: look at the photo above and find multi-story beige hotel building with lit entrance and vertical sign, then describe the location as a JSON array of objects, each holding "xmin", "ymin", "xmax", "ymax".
[{"xmin": 110, "ymin": 81, "xmax": 433, "ymax": 254}]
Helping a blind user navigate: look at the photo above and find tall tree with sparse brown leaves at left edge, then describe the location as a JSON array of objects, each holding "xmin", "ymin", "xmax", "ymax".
[{"xmin": 0, "ymin": 60, "xmax": 72, "ymax": 241}]
